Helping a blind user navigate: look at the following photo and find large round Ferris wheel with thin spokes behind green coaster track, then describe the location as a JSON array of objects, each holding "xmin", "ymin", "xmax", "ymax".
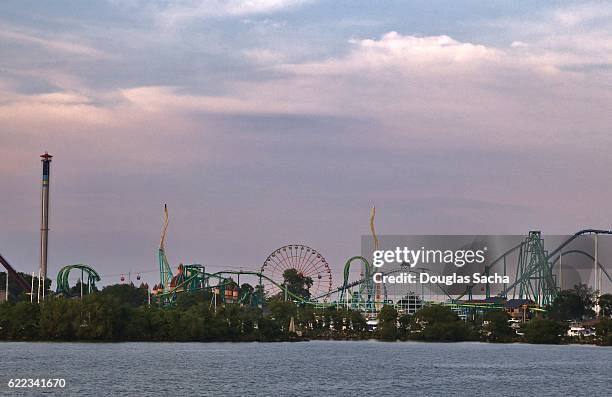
[{"xmin": 261, "ymin": 244, "xmax": 332, "ymax": 297}]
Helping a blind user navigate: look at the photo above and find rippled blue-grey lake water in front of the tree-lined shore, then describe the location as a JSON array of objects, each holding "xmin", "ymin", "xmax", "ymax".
[{"xmin": 0, "ymin": 341, "xmax": 612, "ymax": 397}]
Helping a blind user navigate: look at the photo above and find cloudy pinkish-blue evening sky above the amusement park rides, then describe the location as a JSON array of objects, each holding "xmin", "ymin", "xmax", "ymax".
[{"xmin": 0, "ymin": 0, "xmax": 612, "ymax": 284}]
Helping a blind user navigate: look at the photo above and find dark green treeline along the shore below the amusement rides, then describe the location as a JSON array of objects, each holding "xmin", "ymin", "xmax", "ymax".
[{"xmin": 0, "ymin": 284, "xmax": 612, "ymax": 345}]
